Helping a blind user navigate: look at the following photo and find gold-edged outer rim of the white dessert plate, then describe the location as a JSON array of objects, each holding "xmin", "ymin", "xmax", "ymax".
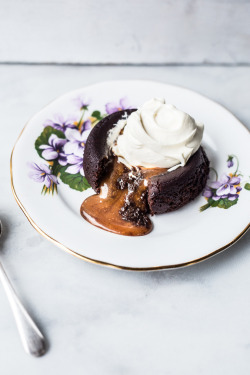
[{"xmin": 10, "ymin": 79, "xmax": 250, "ymax": 272}]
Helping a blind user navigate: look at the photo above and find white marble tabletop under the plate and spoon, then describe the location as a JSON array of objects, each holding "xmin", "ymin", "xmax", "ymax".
[{"xmin": 0, "ymin": 66, "xmax": 250, "ymax": 375}]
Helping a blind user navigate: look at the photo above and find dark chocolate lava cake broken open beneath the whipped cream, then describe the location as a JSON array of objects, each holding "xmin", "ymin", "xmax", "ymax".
[{"xmin": 83, "ymin": 109, "xmax": 209, "ymax": 235}]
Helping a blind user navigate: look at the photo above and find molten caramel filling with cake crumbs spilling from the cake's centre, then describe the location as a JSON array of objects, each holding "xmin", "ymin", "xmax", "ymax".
[{"xmin": 80, "ymin": 158, "xmax": 167, "ymax": 236}]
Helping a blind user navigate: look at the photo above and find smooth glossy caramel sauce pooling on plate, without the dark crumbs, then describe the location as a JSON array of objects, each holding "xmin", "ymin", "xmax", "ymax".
[{"xmin": 80, "ymin": 160, "xmax": 166, "ymax": 236}]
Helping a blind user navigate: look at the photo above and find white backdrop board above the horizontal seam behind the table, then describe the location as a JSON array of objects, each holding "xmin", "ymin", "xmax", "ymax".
[{"xmin": 0, "ymin": 0, "xmax": 250, "ymax": 63}]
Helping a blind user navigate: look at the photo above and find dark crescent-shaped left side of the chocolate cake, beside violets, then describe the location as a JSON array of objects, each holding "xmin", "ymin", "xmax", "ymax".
[{"xmin": 83, "ymin": 109, "xmax": 136, "ymax": 193}]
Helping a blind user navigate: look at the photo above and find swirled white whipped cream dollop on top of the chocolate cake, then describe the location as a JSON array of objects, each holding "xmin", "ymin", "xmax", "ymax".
[{"xmin": 107, "ymin": 98, "xmax": 204, "ymax": 170}]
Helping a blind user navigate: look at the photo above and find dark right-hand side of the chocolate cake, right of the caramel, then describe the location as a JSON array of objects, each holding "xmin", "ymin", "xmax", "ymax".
[{"xmin": 148, "ymin": 147, "xmax": 209, "ymax": 215}]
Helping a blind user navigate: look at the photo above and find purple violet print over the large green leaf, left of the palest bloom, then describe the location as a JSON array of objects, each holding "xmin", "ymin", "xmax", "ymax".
[{"xmin": 40, "ymin": 134, "xmax": 67, "ymax": 166}]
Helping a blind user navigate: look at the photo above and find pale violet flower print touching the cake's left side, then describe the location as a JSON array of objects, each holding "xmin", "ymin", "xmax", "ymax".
[{"xmin": 64, "ymin": 129, "xmax": 89, "ymax": 157}]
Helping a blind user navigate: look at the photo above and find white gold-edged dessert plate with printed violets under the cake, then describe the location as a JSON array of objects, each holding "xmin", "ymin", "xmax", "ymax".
[{"xmin": 11, "ymin": 81, "xmax": 250, "ymax": 271}]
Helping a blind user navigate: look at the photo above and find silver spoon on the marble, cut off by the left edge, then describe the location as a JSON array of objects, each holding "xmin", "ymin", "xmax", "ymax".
[{"xmin": 0, "ymin": 221, "xmax": 45, "ymax": 357}]
